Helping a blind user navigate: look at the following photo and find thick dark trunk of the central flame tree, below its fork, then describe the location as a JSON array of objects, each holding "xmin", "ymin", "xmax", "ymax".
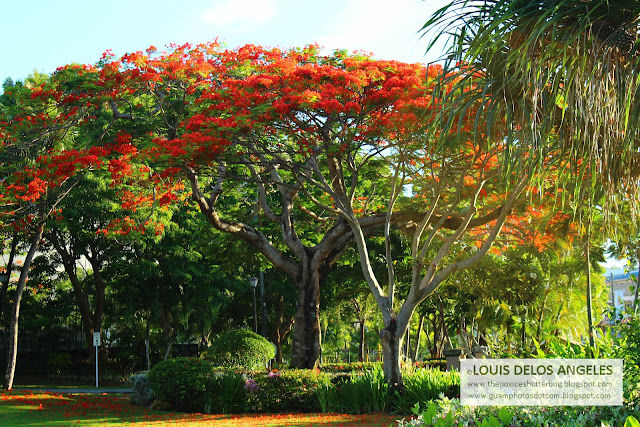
[{"xmin": 291, "ymin": 266, "xmax": 320, "ymax": 369}]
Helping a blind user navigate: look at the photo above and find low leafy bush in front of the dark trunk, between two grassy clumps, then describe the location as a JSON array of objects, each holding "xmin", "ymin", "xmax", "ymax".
[{"xmin": 250, "ymin": 369, "xmax": 330, "ymax": 412}]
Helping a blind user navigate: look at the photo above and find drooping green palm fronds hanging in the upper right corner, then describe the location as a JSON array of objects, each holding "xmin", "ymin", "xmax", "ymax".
[{"xmin": 423, "ymin": 0, "xmax": 640, "ymax": 207}]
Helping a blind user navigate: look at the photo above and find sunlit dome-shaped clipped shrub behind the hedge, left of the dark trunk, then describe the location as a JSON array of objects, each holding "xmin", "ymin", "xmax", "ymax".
[{"xmin": 203, "ymin": 329, "xmax": 276, "ymax": 371}]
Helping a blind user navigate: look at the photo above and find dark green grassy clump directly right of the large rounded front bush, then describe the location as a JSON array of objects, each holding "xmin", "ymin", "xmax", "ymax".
[{"xmin": 204, "ymin": 371, "xmax": 249, "ymax": 414}]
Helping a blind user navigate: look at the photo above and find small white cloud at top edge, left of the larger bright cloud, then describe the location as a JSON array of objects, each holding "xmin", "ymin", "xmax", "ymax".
[{"xmin": 203, "ymin": 0, "xmax": 277, "ymax": 31}]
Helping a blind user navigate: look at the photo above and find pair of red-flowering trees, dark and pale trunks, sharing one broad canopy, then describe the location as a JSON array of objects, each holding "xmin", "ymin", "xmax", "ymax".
[{"xmin": 2, "ymin": 42, "xmax": 544, "ymax": 383}]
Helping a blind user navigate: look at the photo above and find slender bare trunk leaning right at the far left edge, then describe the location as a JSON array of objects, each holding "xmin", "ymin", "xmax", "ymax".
[{"xmin": 4, "ymin": 220, "xmax": 44, "ymax": 390}]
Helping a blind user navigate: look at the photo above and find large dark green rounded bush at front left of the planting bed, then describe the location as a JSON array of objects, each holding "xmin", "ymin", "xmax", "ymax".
[{"xmin": 149, "ymin": 357, "xmax": 213, "ymax": 412}]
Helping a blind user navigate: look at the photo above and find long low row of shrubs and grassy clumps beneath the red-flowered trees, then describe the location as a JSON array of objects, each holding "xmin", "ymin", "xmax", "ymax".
[{"xmin": 141, "ymin": 357, "xmax": 459, "ymax": 413}]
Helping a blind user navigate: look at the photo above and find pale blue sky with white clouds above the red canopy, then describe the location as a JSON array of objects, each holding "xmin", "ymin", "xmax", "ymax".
[{"xmin": 0, "ymin": 0, "xmax": 447, "ymax": 82}]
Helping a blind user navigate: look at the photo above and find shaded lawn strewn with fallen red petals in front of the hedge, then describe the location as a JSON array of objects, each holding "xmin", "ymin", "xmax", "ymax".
[{"xmin": 0, "ymin": 390, "xmax": 397, "ymax": 427}]
